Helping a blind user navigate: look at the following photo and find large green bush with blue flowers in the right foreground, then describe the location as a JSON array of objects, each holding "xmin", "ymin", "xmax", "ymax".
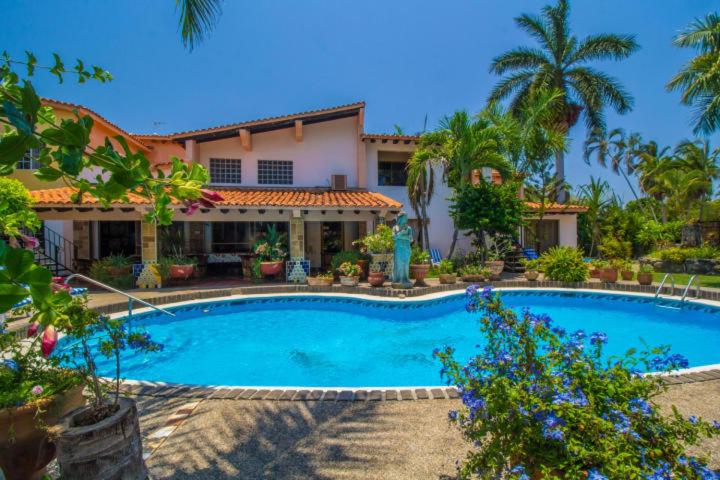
[{"xmin": 435, "ymin": 286, "xmax": 720, "ymax": 480}]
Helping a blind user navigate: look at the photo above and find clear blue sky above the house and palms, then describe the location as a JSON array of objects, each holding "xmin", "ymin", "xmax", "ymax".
[{"xmin": 0, "ymin": 0, "xmax": 720, "ymax": 199}]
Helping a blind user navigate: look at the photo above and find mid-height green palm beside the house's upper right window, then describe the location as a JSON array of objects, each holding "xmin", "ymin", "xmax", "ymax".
[{"xmin": 415, "ymin": 110, "xmax": 512, "ymax": 256}]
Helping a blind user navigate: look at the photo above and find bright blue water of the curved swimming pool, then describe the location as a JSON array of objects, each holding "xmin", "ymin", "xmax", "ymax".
[{"xmin": 63, "ymin": 290, "xmax": 720, "ymax": 387}]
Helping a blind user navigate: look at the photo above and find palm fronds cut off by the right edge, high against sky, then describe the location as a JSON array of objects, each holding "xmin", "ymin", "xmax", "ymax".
[{"xmin": 667, "ymin": 13, "xmax": 720, "ymax": 134}]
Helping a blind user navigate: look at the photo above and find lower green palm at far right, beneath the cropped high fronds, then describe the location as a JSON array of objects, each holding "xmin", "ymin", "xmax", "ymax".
[{"xmin": 675, "ymin": 140, "xmax": 720, "ymax": 221}]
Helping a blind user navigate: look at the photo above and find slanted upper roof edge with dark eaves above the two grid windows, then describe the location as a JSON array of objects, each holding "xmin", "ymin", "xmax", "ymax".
[{"xmin": 134, "ymin": 101, "xmax": 365, "ymax": 142}]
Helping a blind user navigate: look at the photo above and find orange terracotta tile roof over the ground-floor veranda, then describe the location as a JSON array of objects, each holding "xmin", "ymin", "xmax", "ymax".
[{"xmin": 30, "ymin": 187, "xmax": 402, "ymax": 209}]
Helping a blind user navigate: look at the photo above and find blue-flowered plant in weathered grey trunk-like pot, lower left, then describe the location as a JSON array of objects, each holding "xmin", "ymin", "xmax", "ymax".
[{"xmin": 52, "ymin": 297, "xmax": 162, "ymax": 480}]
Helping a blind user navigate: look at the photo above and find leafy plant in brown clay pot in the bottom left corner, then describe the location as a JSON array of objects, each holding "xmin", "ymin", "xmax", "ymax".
[{"xmin": 0, "ymin": 328, "xmax": 85, "ymax": 479}]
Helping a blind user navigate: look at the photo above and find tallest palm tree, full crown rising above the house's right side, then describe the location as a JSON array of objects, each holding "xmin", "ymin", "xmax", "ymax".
[{"xmin": 490, "ymin": 0, "xmax": 638, "ymax": 197}]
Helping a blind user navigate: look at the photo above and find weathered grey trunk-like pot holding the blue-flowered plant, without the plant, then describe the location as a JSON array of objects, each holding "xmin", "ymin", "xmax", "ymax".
[{"xmin": 55, "ymin": 398, "xmax": 148, "ymax": 480}]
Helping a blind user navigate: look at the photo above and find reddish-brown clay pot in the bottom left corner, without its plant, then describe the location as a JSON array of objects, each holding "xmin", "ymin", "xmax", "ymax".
[{"xmin": 0, "ymin": 385, "xmax": 85, "ymax": 479}]
